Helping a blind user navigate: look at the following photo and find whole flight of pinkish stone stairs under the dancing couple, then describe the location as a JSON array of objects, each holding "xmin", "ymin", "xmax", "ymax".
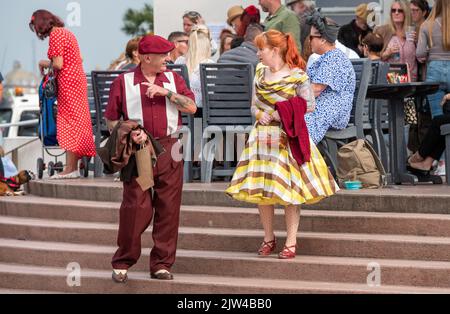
[{"xmin": 0, "ymin": 179, "xmax": 450, "ymax": 293}]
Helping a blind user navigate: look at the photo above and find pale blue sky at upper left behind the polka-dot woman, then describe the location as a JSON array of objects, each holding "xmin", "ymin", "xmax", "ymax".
[{"xmin": 0, "ymin": 0, "xmax": 153, "ymax": 75}]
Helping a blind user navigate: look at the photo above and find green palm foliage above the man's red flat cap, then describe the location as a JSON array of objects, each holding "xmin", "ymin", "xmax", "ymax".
[{"xmin": 122, "ymin": 4, "xmax": 153, "ymax": 37}]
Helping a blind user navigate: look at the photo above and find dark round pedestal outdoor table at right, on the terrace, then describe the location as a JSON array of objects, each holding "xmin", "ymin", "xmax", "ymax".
[{"xmin": 366, "ymin": 82, "xmax": 439, "ymax": 184}]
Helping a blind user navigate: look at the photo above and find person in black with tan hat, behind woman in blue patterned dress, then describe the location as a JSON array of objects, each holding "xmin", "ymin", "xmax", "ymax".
[{"xmin": 338, "ymin": 3, "xmax": 372, "ymax": 58}]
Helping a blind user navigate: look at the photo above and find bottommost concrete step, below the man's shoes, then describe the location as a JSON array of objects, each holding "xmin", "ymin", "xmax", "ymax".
[{"xmin": 0, "ymin": 263, "xmax": 450, "ymax": 294}]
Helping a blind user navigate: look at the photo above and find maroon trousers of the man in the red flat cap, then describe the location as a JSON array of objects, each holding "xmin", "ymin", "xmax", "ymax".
[{"xmin": 112, "ymin": 138, "xmax": 183, "ymax": 273}]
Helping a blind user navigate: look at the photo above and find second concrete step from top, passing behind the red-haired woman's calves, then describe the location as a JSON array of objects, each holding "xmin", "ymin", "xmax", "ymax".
[{"xmin": 0, "ymin": 195, "xmax": 450, "ymax": 237}]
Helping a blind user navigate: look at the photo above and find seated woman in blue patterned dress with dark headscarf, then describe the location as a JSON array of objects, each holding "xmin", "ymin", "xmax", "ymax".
[{"xmin": 305, "ymin": 11, "xmax": 356, "ymax": 144}]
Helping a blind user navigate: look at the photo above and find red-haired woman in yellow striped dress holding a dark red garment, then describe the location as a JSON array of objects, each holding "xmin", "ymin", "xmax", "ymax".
[{"xmin": 226, "ymin": 30, "xmax": 338, "ymax": 259}]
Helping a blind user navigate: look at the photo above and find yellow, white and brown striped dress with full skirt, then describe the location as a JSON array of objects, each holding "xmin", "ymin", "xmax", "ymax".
[{"xmin": 225, "ymin": 63, "xmax": 339, "ymax": 205}]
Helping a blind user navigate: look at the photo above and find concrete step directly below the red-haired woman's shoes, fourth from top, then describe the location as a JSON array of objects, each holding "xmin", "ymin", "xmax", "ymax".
[{"xmin": 0, "ymin": 239, "xmax": 450, "ymax": 288}]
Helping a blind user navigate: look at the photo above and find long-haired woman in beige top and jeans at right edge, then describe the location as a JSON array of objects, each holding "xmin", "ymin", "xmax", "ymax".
[{"xmin": 416, "ymin": 0, "xmax": 450, "ymax": 117}]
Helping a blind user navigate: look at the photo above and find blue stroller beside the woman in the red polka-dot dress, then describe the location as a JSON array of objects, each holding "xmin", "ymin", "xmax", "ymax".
[{"xmin": 37, "ymin": 74, "xmax": 65, "ymax": 179}]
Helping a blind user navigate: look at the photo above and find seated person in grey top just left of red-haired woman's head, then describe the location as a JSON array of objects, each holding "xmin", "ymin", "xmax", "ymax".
[{"xmin": 217, "ymin": 24, "xmax": 263, "ymax": 69}]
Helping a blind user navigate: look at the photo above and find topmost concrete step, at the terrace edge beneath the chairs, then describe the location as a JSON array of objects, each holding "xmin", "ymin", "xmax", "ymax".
[{"xmin": 27, "ymin": 178, "xmax": 450, "ymax": 214}]
